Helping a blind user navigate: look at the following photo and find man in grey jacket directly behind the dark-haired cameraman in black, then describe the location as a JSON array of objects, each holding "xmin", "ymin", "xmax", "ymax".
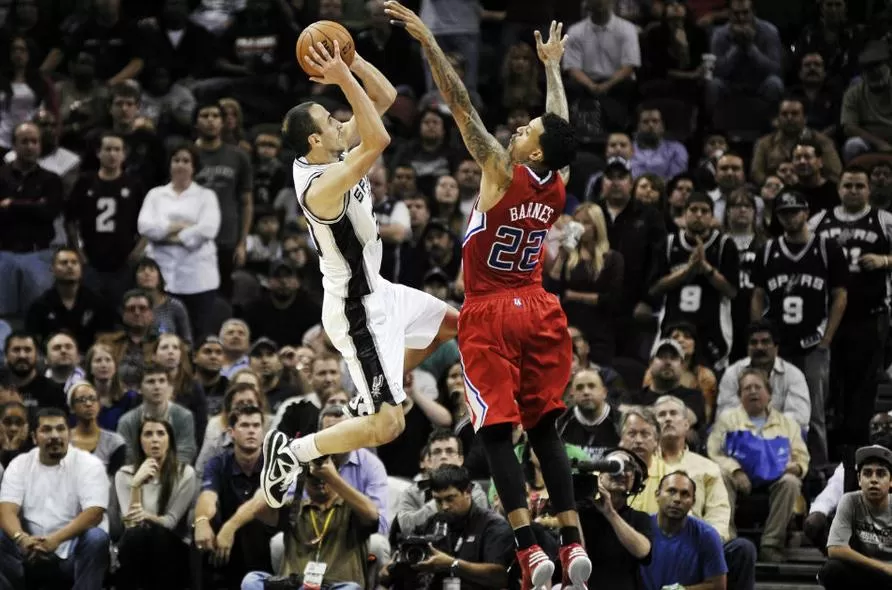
[{"xmin": 395, "ymin": 429, "xmax": 489, "ymax": 531}]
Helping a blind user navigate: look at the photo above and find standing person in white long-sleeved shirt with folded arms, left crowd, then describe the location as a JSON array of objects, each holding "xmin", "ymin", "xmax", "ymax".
[{"xmin": 137, "ymin": 144, "xmax": 221, "ymax": 335}]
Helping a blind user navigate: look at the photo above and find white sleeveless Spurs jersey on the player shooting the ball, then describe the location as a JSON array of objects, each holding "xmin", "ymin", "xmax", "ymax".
[{"xmin": 293, "ymin": 157, "xmax": 382, "ymax": 298}]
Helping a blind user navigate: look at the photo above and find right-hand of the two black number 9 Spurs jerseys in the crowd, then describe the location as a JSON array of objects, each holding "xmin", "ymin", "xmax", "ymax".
[{"xmin": 753, "ymin": 234, "xmax": 848, "ymax": 359}]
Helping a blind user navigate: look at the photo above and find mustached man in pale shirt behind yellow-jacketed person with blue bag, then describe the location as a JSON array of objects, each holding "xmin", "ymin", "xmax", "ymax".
[{"xmin": 715, "ymin": 320, "xmax": 811, "ymax": 433}]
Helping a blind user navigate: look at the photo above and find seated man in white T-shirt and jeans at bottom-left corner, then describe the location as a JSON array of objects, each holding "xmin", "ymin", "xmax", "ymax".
[{"xmin": 0, "ymin": 408, "xmax": 109, "ymax": 590}]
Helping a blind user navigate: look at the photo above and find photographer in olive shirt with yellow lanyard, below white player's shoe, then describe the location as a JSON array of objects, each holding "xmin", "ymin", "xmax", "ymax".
[{"xmin": 241, "ymin": 457, "xmax": 378, "ymax": 590}]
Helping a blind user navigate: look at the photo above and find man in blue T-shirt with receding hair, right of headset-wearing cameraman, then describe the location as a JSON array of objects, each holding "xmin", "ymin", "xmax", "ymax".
[{"xmin": 641, "ymin": 471, "xmax": 728, "ymax": 590}]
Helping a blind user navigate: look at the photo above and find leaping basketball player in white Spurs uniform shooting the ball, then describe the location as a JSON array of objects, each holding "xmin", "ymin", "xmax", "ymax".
[{"xmin": 261, "ymin": 42, "xmax": 458, "ymax": 508}]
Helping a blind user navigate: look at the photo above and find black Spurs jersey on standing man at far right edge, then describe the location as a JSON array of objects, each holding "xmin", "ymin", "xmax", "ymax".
[{"xmin": 808, "ymin": 205, "xmax": 892, "ymax": 318}]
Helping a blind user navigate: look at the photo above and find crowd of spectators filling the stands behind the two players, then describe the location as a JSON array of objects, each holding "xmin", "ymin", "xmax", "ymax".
[{"xmin": 0, "ymin": 0, "xmax": 892, "ymax": 590}]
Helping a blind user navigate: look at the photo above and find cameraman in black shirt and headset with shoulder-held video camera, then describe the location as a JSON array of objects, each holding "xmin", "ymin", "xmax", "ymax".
[{"xmin": 575, "ymin": 448, "xmax": 652, "ymax": 590}]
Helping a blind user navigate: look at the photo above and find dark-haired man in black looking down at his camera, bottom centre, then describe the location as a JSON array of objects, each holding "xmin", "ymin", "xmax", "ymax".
[{"xmin": 380, "ymin": 464, "xmax": 514, "ymax": 590}]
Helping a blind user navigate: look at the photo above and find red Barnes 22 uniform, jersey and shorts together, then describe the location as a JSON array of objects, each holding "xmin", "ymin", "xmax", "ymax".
[{"xmin": 458, "ymin": 165, "xmax": 573, "ymax": 431}]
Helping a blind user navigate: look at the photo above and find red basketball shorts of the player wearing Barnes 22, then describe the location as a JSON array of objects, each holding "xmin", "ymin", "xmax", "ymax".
[{"xmin": 458, "ymin": 285, "xmax": 573, "ymax": 431}]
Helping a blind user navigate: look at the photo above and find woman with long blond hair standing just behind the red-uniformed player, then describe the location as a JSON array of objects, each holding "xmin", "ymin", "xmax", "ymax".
[{"xmin": 549, "ymin": 203, "xmax": 623, "ymax": 366}]
